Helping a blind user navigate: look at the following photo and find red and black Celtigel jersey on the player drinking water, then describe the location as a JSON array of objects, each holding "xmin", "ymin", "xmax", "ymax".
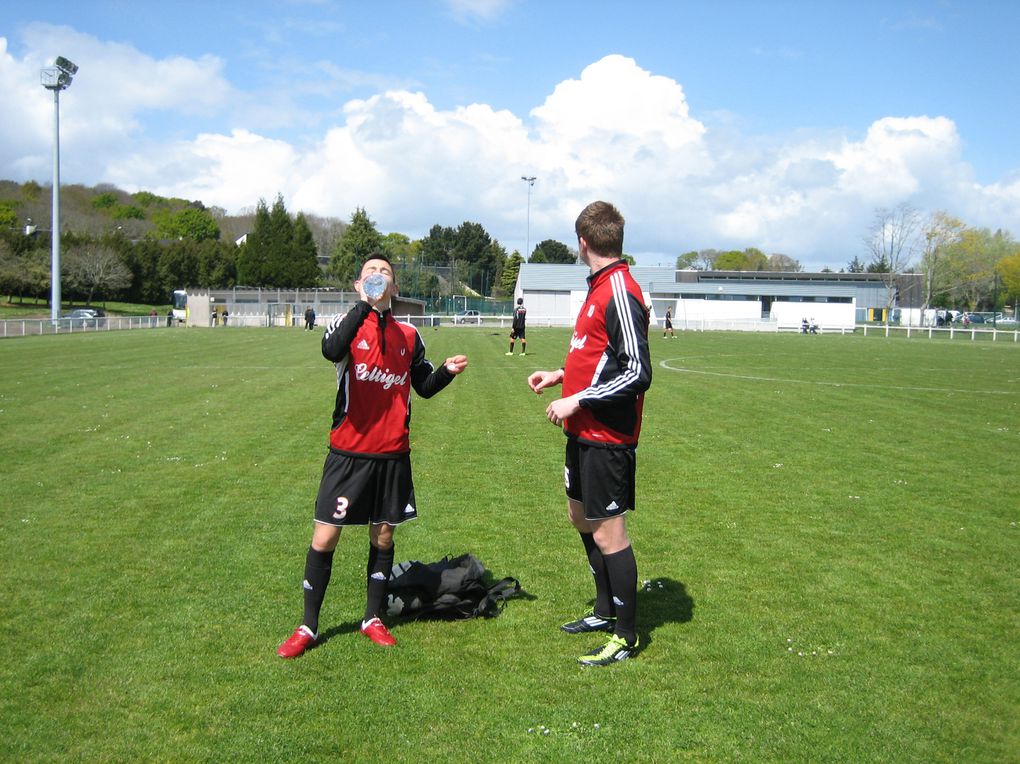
[{"xmin": 322, "ymin": 300, "xmax": 454, "ymax": 456}]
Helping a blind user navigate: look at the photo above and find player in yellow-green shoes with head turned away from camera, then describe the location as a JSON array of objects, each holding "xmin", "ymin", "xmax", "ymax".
[{"xmin": 527, "ymin": 202, "xmax": 652, "ymax": 666}]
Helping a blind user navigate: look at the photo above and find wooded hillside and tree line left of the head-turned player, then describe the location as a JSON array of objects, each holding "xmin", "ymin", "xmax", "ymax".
[{"xmin": 0, "ymin": 182, "xmax": 542, "ymax": 304}]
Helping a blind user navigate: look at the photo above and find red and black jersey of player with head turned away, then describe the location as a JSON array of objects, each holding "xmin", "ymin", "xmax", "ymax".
[{"xmin": 563, "ymin": 260, "xmax": 652, "ymax": 447}]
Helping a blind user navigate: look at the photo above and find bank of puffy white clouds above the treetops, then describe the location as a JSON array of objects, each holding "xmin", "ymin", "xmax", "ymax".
[{"xmin": 0, "ymin": 32, "xmax": 1020, "ymax": 267}]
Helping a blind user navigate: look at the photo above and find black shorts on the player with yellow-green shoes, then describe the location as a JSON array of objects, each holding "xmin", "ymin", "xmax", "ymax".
[{"xmin": 563, "ymin": 438, "xmax": 638, "ymax": 520}]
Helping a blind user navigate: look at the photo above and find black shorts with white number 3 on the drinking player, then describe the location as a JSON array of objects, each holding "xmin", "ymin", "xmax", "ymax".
[{"xmin": 315, "ymin": 451, "xmax": 418, "ymax": 526}]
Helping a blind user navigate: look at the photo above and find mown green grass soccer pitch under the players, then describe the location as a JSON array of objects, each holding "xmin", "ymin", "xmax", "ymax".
[{"xmin": 0, "ymin": 328, "xmax": 1020, "ymax": 762}]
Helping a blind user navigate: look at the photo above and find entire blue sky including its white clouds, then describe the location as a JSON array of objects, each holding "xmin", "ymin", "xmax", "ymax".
[{"xmin": 0, "ymin": 0, "xmax": 1020, "ymax": 269}]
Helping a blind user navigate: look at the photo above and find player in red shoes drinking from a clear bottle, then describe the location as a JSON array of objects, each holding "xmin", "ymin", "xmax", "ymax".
[{"xmin": 276, "ymin": 254, "xmax": 467, "ymax": 658}]
